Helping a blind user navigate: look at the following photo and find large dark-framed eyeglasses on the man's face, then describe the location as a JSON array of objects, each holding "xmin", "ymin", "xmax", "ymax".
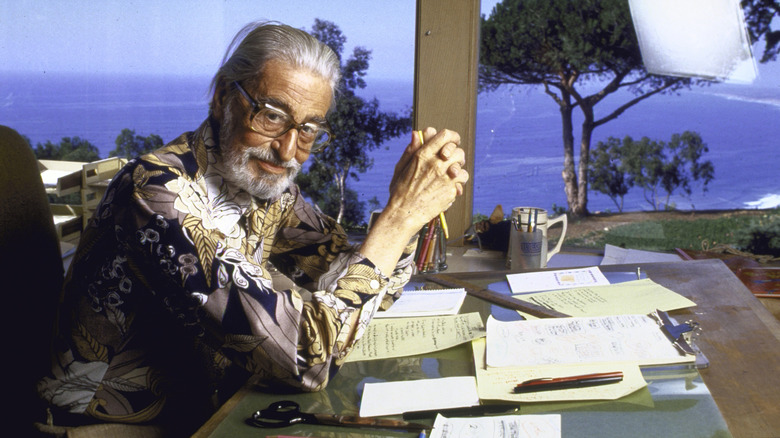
[{"xmin": 233, "ymin": 81, "xmax": 333, "ymax": 152}]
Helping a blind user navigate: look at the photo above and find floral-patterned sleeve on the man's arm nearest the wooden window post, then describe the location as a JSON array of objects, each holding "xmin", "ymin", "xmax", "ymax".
[{"xmin": 270, "ymin": 188, "xmax": 416, "ymax": 384}]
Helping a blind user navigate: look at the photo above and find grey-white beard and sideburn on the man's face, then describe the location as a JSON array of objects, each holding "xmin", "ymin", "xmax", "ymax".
[{"xmin": 219, "ymin": 104, "xmax": 301, "ymax": 199}]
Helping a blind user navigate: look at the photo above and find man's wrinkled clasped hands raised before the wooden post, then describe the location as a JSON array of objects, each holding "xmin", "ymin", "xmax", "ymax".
[{"xmin": 386, "ymin": 128, "xmax": 469, "ymax": 231}]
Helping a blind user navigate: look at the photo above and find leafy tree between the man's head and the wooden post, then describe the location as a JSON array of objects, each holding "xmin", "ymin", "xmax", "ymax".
[{"xmin": 296, "ymin": 19, "xmax": 411, "ymax": 226}]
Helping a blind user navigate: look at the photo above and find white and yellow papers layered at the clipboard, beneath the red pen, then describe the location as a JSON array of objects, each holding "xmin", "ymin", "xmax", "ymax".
[{"xmin": 472, "ymin": 315, "xmax": 696, "ymax": 402}]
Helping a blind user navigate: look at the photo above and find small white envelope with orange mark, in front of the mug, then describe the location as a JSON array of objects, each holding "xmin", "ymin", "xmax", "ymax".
[{"xmin": 506, "ymin": 266, "xmax": 609, "ymax": 294}]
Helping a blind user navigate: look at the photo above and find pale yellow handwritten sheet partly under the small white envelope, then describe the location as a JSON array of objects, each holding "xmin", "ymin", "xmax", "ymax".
[{"xmin": 518, "ymin": 278, "xmax": 696, "ymax": 316}]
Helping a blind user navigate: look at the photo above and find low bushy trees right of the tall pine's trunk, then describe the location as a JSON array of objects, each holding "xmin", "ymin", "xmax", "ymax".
[{"xmin": 589, "ymin": 131, "xmax": 715, "ymax": 211}]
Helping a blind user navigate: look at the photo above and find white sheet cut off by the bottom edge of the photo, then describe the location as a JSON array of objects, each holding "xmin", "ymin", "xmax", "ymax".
[{"xmin": 430, "ymin": 414, "xmax": 561, "ymax": 438}]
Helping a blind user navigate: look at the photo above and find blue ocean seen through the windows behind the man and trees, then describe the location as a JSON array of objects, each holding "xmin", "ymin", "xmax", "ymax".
[{"xmin": 0, "ymin": 73, "xmax": 780, "ymax": 222}]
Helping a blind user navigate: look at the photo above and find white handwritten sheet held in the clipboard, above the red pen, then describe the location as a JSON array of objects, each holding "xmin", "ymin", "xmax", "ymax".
[{"xmin": 486, "ymin": 315, "xmax": 695, "ymax": 367}]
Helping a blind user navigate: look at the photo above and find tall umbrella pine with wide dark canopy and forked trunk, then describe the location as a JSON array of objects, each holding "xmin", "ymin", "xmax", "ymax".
[{"xmin": 479, "ymin": 0, "xmax": 691, "ymax": 216}]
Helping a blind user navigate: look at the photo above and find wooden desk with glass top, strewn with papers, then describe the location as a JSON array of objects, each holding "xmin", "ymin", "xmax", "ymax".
[{"xmin": 195, "ymin": 260, "xmax": 780, "ymax": 438}]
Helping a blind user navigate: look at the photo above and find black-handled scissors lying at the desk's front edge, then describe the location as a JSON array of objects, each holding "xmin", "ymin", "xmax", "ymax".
[{"xmin": 246, "ymin": 400, "xmax": 430, "ymax": 431}]
